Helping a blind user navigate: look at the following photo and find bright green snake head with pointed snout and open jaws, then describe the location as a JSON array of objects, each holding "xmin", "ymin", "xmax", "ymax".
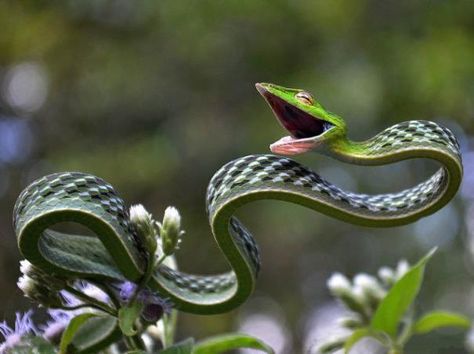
[{"xmin": 255, "ymin": 83, "xmax": 346, "ymax": 155}]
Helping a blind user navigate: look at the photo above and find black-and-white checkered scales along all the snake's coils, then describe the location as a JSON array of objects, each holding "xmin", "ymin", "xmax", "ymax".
[{"xmin": 14, "ymin": 121, "xmax": 461, "ymax": 297}]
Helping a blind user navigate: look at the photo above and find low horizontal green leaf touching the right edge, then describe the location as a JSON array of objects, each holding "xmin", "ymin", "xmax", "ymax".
[{"xmin": 413, "ymin": 311, "xmax": 471, "ymax": 334}]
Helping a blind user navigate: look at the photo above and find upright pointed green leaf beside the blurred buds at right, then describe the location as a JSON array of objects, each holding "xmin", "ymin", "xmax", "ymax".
[{"xmin": 370, "ymin": 249, "xmax": 436, "ymax": 338}]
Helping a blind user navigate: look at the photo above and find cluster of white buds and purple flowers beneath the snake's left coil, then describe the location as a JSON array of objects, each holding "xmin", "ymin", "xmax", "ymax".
[{"xmin": 0, "ymin": 205, "xmax": 184, "ymax": 354}]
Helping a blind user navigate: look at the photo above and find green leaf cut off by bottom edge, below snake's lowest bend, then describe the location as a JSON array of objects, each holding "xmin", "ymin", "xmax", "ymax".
[{"xmin": 193, "ymin": 333, "xmax": 274, "ymax": 354}]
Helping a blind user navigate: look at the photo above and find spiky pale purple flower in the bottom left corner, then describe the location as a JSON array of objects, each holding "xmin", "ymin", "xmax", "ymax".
[{"xmin": 0, "ymin": 310, "xmax": 38, "ymax": 354}]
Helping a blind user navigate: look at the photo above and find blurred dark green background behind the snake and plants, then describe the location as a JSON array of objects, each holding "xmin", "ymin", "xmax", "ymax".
[{"xmin": 0, "ymin": 0, "xmax": 474, "ymax": 354}]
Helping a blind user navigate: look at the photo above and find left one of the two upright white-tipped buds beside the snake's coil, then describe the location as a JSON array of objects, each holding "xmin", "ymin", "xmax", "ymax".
[{"xmin": 130, "ymin": 204, "xmax": 158, "ymax": 254}]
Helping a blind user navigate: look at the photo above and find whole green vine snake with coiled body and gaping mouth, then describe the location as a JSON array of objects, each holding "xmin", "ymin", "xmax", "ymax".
[{"xmin": 14, "ymin": 83, "xmax": 462, "ymax": 314}]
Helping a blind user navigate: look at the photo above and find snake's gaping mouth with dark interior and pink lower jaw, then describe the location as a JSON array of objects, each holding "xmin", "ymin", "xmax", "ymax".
[{"xmin": 256, "ymin": 84, "xmax": 333, "ymax": 155}]
